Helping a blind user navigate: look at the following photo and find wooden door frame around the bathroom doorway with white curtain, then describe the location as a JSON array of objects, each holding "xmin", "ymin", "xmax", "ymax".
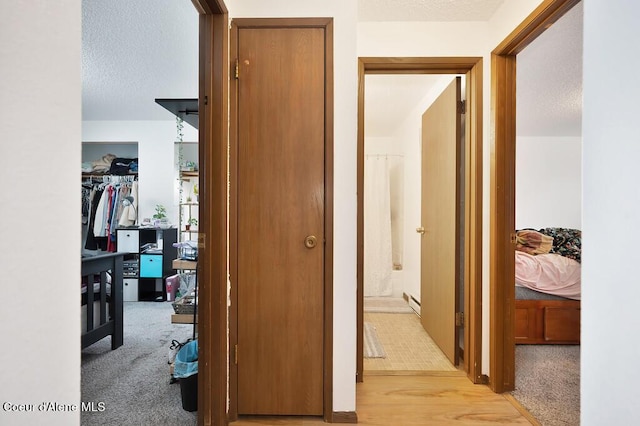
[{"xmin": 356, "ymin": 57, "xmax": 484, "ymax": 383}]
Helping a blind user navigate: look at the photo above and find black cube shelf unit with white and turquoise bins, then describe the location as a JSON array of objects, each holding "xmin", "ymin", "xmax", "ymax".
[{"xmin": 116, "ymin": 228, "xmax": 178, "ymax": 302}]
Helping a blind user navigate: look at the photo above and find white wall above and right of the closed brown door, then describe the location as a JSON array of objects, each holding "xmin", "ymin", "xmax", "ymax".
[{"xmin": 227, "ymin": 0, "xmax": 358, "ymax": 411}]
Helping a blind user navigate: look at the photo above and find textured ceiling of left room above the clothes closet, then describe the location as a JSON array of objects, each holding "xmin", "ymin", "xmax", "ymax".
[{"xmin": 82, "ymin": 0, "xmax": 198, "ymax": 120}]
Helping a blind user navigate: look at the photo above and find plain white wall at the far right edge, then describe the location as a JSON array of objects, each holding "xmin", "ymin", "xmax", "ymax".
[{"xmin": 580, "ymin": 0, "xmax": 640, "ymax": 426}]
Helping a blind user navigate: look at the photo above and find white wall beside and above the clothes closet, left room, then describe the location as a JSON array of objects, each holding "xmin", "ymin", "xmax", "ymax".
[{"xmin": 82, "ymin": 120, "xmax": 198, "ymax": 225}]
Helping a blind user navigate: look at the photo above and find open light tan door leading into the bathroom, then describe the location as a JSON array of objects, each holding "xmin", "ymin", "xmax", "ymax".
[{"xmin": 420, "ymin": 77, "xmax": 461, "ymax": 365}]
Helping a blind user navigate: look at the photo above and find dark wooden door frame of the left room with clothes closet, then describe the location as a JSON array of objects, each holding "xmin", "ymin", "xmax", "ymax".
[{"xmin": 192, "ymin": 0, "xmax": 229, "ymax": 425}]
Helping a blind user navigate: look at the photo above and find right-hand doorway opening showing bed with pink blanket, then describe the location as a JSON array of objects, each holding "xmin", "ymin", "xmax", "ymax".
[{"xmin": 511, "ymin": 3, "xmax": 582, "ymax": 424}]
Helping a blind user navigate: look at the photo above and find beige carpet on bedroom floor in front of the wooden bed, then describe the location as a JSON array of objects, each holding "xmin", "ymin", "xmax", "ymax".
[{"xmin": 511, "ymin": 345, "xmax": 580, "ymax": 426}]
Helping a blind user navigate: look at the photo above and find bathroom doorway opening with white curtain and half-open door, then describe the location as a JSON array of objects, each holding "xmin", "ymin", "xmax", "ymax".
[{"xmin": 363, "ymin": 74, "xmax": 462, "ymax": 374}]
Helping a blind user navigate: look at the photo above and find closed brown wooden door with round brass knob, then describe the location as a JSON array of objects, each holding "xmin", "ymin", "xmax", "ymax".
[{"xmin": 236, "ymin": 27, "xmax": 325, "ymax": 415}]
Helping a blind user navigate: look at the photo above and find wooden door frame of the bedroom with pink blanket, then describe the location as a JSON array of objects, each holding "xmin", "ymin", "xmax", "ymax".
[{"xmin": 489, "ymin": 0, "xmax": 580, "ymax": 393}]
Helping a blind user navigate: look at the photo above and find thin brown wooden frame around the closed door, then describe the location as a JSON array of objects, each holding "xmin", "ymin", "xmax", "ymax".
[{"xmin": 225, "ymin": 18, "xmax": 336, "ymax": 423}]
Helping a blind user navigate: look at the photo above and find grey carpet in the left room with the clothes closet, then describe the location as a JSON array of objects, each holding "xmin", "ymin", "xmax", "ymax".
[{"xmin": 81, "ymin": 302, "xmax": 197, "ymax": 426}]
